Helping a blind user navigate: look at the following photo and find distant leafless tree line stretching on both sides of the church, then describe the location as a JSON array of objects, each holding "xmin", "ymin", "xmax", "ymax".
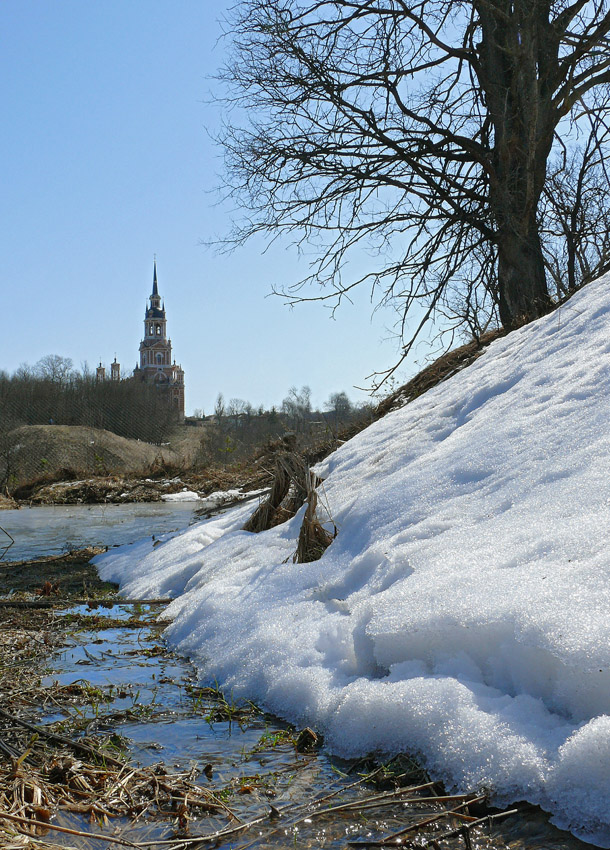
[{"xmin": 0, "ymin": 355, "xmax": 372, "ymax": 489}]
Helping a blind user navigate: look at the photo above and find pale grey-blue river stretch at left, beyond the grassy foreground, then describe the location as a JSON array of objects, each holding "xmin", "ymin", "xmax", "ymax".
[{"xmin": 0, "ymin": 502, "xmax": 197, "ymax": 561}]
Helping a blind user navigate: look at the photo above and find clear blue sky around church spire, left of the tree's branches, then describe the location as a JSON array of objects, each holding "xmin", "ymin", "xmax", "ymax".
[{"xmin": 0, "ymin": 0, "xmax": 416, "ymax": 413}]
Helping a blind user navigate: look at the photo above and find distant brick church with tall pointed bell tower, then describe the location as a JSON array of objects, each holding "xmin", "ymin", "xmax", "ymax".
[{"xmin": 97, "ymin": 259, "xmax": 184, "ymax": 421}]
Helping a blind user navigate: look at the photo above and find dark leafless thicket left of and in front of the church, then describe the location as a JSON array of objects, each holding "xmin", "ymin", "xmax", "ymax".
[{"xmin": 0, "ymin": 355, "xmax": 175, "ymax": 443}]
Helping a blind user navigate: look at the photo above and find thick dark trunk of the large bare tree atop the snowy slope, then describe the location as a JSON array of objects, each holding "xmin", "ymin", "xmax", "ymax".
[{"xmin": 475, "ymin": 0, "xmax": 557, "ymax": 329}]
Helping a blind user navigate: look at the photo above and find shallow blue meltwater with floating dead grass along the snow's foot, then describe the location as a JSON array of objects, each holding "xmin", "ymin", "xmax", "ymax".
[{"xmin": 42, "ymin": 606, "xmax": 590, "ymax": 850}]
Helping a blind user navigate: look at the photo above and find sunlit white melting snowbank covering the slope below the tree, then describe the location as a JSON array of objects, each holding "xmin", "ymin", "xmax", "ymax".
[{"xmin": 99, "ymin": 276, "xmax": 610, "ymax": 847}]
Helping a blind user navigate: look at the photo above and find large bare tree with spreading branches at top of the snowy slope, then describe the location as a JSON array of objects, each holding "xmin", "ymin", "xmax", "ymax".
[{"xmin": 220, "ymin": 0, "xmax": 610, "ymax": 380}]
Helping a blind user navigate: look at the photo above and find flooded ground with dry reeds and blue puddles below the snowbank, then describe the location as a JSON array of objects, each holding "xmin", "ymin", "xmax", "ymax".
[{"xmin": 0, "ymin": 550, "xmax": 532, "ymax": 850}]
